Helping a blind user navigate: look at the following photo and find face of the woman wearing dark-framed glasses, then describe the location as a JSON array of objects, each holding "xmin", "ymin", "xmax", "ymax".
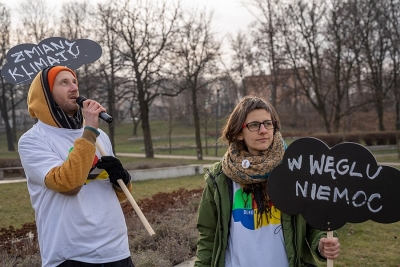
[{"xmin": 238, "ymin": 109, "xmax": 274, "ymax": 156}]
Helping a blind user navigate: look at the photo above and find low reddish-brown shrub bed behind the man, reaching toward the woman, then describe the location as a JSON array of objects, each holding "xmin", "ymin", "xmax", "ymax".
[{"xmin": 0, "ymin": 188, "xmax": 203, "ymax": 267}]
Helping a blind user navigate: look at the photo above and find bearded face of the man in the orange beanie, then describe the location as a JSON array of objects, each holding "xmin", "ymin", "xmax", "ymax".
[{"xmin": 51, "ymin": 71, "xmax": 79, "ymax": 116}]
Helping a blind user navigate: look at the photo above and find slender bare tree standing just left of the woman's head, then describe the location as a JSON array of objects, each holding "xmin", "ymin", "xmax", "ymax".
[{"xmin": 173, "ymin": 9, "xmax": 221, "ymax": 160}]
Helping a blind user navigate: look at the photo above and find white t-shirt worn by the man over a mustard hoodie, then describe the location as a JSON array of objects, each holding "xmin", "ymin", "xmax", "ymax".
[{"xmin": 18, "ymin": 121, "xmax": 130, "ymax": 267}]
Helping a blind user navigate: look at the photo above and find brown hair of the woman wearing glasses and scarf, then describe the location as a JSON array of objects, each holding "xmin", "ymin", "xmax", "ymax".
[{"xmin": 221, "ymin": 96, "xmax": 281, "ymax": 149}]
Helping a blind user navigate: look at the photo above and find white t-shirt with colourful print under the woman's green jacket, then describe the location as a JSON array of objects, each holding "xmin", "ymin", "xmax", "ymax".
[{"xmin": 225, "ymin": 182, "xmax": 289, "ymax": 267}]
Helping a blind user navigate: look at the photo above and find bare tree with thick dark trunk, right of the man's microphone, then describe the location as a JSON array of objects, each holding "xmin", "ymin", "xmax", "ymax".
[{"xmin": 114, "ymin": 0, "xmax": 180, "ymax": 158}]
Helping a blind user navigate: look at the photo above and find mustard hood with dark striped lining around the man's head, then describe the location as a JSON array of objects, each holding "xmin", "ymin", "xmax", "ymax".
[{"xmin": 27, "ymin": 66, "xmax": 83, "ymax": 129}]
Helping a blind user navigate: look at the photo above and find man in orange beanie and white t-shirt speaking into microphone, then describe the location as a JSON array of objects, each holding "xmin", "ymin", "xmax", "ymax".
[{"xmin": 18, "ymin": 66, "xmax": 133, "ymax": 267}]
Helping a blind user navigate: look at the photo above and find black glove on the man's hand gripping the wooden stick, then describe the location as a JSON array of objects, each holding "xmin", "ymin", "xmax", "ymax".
[{"xmin": 96, "ymin": 156, "xmax": 131, "ymax": 187}]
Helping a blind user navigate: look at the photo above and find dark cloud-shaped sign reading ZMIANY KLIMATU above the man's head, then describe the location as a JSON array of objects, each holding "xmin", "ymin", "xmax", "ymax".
[{"xmin": 1, "ymin": 37, "xmax": 102, "ymax": 84}]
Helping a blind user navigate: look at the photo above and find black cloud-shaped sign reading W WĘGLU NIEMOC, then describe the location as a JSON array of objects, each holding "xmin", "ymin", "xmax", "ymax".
[{"xmin": 268, "ymin": 137, "xmax": 400, "ymax": 231}]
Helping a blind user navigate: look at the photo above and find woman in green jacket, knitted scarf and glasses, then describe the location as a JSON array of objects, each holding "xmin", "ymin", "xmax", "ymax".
[{"xmin": 195, "ymin": 96, "xmax": 340, "ymax": 267}]
